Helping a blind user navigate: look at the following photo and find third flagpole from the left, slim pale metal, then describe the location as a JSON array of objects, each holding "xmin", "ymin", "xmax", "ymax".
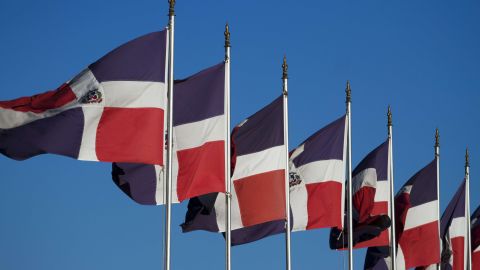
[{"xmin": 282, "ymin": 56, "xmax": 292, "ymax": 270}]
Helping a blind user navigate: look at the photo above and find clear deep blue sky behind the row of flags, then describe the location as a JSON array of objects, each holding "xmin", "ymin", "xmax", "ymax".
[{"xmin": 0, "ymin": 0, "xmax": 480, "ymax": 270}]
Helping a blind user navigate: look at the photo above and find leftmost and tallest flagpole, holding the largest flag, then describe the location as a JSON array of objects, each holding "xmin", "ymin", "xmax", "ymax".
[{"xmin": 164, "ymin": 0, "xmax": 175, "ymax": 270}]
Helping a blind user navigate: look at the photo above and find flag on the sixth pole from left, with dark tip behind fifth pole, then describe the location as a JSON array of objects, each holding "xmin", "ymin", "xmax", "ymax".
[{"xmin": 364, "ymin": 160, "xmax": 440, "ymax": 270}]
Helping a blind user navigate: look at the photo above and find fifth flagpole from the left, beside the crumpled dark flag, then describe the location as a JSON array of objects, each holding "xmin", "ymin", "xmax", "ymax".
[{"xmin": 387, "ymin": 105, "xmax": 397, "ymax": 270}]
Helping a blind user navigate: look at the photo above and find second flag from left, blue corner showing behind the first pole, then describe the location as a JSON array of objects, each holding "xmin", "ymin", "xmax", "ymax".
[{"xmin": 112, "ymin": 62, "xmax": 228, "ymax": 205}]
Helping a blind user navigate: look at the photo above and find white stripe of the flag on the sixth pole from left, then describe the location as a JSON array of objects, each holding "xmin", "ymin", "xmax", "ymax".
[{"xmin": 404, "ymin": 200, "xmax": 438, "ymax": 231}]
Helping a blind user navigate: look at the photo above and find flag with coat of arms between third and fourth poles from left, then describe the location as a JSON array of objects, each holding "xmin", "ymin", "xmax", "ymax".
[{"xmin": 290, "ymin": 116, "xmax": 348, "ymax": 231}]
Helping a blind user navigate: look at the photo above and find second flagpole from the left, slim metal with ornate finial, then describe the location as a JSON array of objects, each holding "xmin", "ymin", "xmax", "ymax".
[{"xmin": 224, "ymin": 23, "xmax": 232, "ymax": 270}]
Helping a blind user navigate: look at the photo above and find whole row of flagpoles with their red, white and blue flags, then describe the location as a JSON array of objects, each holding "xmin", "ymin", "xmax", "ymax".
[{"xmin": 0, "ymin": 0, "xmax": 480, "ymax": 270}]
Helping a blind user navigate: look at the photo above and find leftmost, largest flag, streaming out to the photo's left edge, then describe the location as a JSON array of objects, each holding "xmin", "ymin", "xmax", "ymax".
[{"xmin": 0, "ymin": 31, "xmax": 167, "ymax": 164}]
